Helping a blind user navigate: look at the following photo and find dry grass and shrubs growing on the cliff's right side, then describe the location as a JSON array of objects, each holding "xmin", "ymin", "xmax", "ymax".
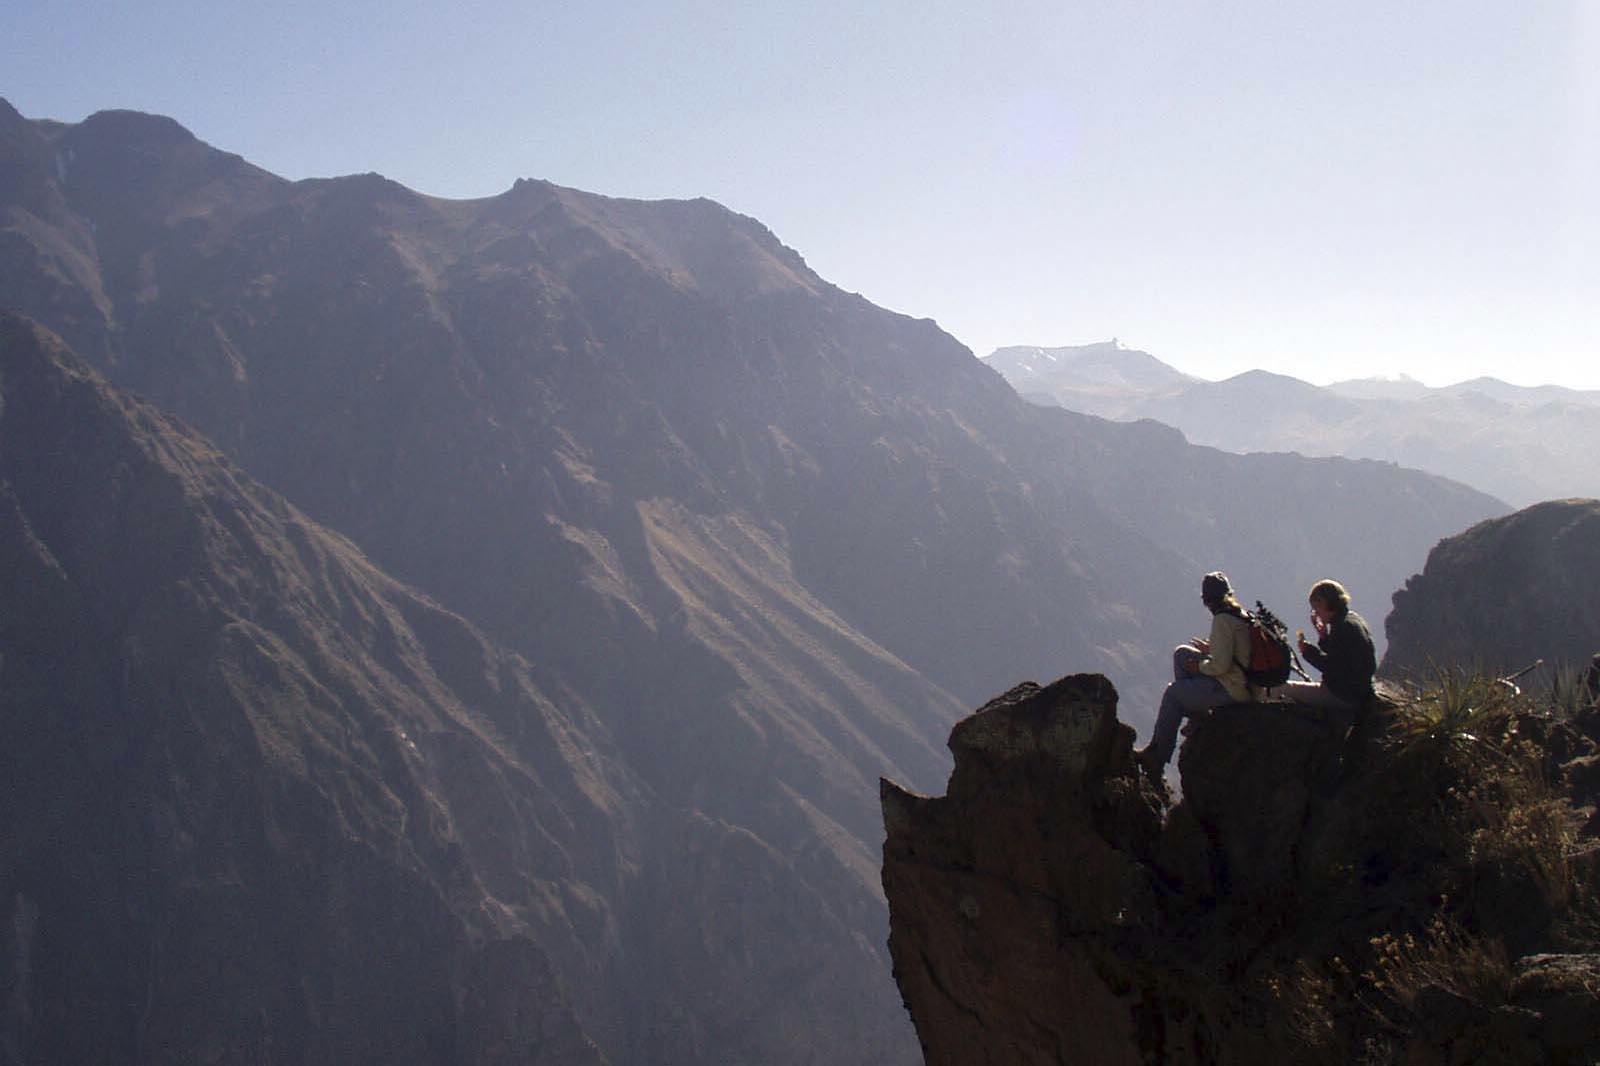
[{"xmin": 1282, "ymin": 671, "xmax": 1600, "ymax": 1063}]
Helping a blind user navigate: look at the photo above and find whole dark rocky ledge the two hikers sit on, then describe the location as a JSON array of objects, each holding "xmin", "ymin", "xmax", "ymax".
[{"xmin": 882, "ymin": 675, "xmax": 1600, "ymax": 1066}]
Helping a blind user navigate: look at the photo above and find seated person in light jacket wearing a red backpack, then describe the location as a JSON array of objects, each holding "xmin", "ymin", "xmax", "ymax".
[{"xmin": 1134, "ymin": 570, "xmax": 1253, "ymax": 781}]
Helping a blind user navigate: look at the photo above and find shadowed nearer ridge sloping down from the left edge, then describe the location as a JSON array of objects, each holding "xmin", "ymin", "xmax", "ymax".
[{"xmin": 0, "ymin": 315, "xmax": 928, "ymax": 1066}]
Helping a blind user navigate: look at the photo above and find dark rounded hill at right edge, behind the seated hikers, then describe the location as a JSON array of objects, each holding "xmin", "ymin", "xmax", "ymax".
[{"xmin": 1382, "ymin": 499, "xmax": 1600, "ymax": 677}]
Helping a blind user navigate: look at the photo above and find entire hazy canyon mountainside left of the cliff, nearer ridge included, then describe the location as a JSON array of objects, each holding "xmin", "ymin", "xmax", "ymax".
[{"xmin": 0, "ymin": 102, "xmax": 1504, "ymax": 1066}]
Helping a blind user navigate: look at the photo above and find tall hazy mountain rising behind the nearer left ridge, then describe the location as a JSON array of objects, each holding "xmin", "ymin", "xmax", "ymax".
[{"xmin": 0, "ymin": 97, "xmax": 1499, "ymax": 1063}]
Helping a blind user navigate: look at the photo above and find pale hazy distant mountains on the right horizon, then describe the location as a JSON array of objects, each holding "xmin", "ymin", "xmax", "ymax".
[{"xmin": 987, "ymin": 341, "xmax": 1600, "ymax": 506}]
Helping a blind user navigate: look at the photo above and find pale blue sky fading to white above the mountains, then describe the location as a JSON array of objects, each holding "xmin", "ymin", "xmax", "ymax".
[{"xmin": 9, "ymin": 0, "xmax": 1600, "ymax": 389}]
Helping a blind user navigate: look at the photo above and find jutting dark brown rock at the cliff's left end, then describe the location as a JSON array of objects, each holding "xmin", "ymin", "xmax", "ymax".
[{"xmin": 882, "ymin": 675, "xmax": 1182, "ymax": 1066}]
